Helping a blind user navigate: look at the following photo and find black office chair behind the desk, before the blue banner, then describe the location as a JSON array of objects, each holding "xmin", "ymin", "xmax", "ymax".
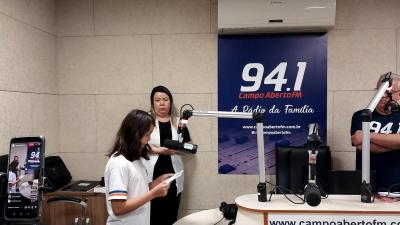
[{"xmin": 275, "ymin": 146, "xmax": 332, "ymax": 194}]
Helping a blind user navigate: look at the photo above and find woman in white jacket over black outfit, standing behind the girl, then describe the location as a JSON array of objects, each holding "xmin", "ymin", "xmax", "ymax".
[{"xmin": 144, "ymin": 86, "xmax": 190, "ymax": 225}]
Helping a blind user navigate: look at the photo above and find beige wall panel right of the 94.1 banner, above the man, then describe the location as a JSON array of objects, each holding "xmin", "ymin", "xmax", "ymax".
[{"xmin": 328, "ymin": 29, "xmax": 396, "ymax": 91}]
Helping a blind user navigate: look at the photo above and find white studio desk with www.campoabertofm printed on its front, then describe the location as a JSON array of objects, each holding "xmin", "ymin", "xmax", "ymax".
[{"xmin": 235, "ymin": 194, "xmax": 400, "ymax": 225}]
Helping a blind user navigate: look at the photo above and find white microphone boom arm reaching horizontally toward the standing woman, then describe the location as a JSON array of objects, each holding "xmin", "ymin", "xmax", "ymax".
[{"xmin": 182, "ymin": 110, "xmax": 267, "ymax": 202}]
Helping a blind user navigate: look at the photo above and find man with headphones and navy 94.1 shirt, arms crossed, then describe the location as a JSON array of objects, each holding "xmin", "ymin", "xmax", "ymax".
[{"xmin": 351, "ymin": 73, "xmax": 400, "ymax": 192}]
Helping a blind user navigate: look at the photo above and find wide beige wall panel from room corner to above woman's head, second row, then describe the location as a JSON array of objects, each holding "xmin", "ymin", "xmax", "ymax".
[{"xmin": 58, "ymin": 35, "xmax": 152, "ymax": 94}]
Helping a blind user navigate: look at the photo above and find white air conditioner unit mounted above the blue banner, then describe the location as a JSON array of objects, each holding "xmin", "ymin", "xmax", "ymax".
[{"xmin": 218, "ymin": 0, "xmax": 336, "ymax": 34}]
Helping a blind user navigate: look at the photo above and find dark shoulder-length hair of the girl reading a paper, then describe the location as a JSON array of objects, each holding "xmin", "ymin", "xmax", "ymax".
[{"xmin": 107, "ymin": 109, "xmax": 155, "ymax": 161}]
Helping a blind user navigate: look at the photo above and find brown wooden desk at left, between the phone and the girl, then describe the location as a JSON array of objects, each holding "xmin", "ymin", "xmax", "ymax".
[{"xmin": 42, "ymin": 191, "xmax": 108, "ymax": 225}]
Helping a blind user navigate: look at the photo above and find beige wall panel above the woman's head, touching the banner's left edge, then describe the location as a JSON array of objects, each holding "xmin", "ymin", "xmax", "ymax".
[{"xmin": 152, "ymin": 35, "xmax": 217, "ymax": 93}]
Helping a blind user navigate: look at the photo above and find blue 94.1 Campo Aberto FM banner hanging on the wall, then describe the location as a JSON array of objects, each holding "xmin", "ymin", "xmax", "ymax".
[{"xmin": 218, "ymin": 34, "xmax": 327, "ymax": 175}]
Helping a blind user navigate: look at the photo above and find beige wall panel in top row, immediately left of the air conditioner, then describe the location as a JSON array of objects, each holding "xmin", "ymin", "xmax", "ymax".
[{"xmin": 94, "ymin": 0, "xmax": 210, "ymax": 35}]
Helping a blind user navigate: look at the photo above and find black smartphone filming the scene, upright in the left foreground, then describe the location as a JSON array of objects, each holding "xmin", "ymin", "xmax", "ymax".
[{"xmin": 5, "ymin": 139, "xmax": 43, "ymax": 219}]
